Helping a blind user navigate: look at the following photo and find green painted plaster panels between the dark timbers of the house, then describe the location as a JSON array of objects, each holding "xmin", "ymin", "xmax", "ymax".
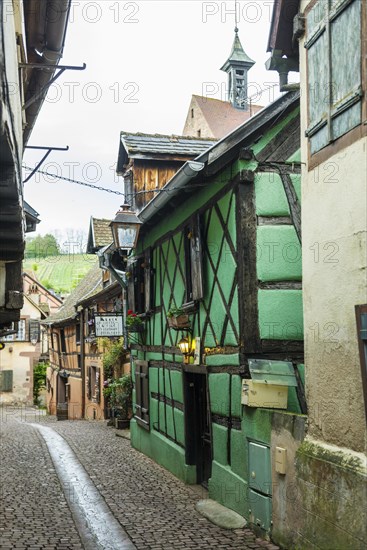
[{"xmin": 132, "ymin": 102, "xmax": 303, "ymax": 532}]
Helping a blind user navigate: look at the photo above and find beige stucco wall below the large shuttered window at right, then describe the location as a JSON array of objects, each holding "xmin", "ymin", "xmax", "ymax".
[{"xmin": 300, "ymin": 2, "xmax": 367, "ymax": 451}]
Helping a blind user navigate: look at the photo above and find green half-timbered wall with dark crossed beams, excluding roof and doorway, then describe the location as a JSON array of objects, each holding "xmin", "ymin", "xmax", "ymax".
[{"xmin": 130, "ymin": 104, "xmax": 306, "ymax": 527}]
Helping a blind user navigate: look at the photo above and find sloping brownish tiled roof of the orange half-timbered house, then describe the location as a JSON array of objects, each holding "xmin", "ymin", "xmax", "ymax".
[{"xmin": 45, "ymin": 260, "xmax": 103, "ymax": 325}]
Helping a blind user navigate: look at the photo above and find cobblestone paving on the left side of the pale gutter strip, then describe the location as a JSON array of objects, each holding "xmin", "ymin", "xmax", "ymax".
[{"xmin": 0, "ymin": 408, "xmax": 82, "ymax": 550}]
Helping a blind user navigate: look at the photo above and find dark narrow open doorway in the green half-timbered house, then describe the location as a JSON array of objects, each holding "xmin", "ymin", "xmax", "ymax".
[{"xmin": 184, "ymin": 372, "xmax": 212, "ymax": 488}]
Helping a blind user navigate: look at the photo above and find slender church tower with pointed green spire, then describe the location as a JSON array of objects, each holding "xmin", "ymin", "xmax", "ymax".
[{"xmin": 221, "ymin": 27, "xmax": 255, "ymax": 111}]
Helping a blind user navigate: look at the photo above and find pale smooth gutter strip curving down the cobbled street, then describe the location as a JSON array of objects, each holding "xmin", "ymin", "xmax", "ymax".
[{"xmin": 29, "ymin": 423, "xmax": 136, "ymax": 550}]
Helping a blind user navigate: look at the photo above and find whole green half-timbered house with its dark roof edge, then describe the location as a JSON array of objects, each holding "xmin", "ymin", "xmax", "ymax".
[{"xmin": 128, "ymin": 92, "xmax": 306, "ymax": 530}]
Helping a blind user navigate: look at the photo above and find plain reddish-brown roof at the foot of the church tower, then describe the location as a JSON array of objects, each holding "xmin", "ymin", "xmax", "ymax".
[{"xmin": 192, "ymin": 95, "xmax": 264, "ymax": 139}]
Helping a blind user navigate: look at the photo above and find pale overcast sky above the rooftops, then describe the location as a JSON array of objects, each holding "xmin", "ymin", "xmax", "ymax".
[{"xmin": 25, "ymin": 0, "xmax": 288, "ymax": 248}]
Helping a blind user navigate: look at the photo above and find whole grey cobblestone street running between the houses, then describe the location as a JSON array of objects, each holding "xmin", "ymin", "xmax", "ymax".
[{"xmin": 0, "ymin": 408, "xmax": 277, "ymax": 550}]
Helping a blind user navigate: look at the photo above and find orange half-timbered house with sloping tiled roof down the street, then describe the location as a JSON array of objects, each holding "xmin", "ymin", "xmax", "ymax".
[{"xmin": 45, "ymin": 263, "xmax": 122, "ymax": 420}]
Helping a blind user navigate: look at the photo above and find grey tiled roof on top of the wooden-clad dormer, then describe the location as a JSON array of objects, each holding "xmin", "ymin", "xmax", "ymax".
[{"xmin": 121, "ymin": 132, "xmax": 215, "ymax": 157}]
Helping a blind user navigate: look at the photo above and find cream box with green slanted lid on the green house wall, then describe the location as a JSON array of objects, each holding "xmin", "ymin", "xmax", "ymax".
[{"xmin": 241, "ymin": 359, "xmax": 297, "ymax": 409}]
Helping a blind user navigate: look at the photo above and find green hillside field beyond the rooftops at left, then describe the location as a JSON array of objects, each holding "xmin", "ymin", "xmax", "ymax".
[{"xmin": 23, "ymin": 254, "xmax": 97, "ymax": 294}]
